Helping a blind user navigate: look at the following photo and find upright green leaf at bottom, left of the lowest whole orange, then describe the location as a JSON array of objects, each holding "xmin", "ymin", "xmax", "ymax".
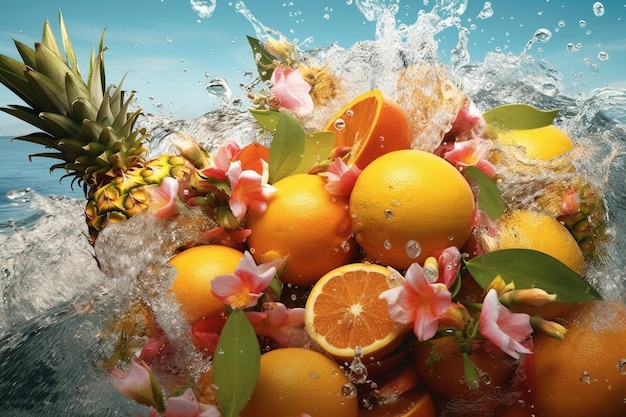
[{"xmin": 213, "ymin": 309, "xmax": 261, "ymax": 417}]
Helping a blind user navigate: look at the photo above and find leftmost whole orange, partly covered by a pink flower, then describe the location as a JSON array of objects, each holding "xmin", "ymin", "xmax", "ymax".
[{"xmin": 168, "ymin": 245, "xmax": 243, "ymax": 324}]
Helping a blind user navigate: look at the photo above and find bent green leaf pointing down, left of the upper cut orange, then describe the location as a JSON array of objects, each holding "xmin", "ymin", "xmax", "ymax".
[{"xmin": 251, "ymin": 110, "xmax": 305, "ymax": 184}]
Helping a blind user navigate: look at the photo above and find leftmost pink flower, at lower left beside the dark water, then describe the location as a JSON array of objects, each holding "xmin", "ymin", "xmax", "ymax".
[{"xmin": 111, "ymin": 358, "xmax": 164, "ymax": 410}]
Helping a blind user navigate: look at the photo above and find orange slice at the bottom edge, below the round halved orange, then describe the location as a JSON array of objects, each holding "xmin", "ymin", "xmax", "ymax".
[{"xmin": 359, "ymin": 390, "xmax": 437, "ymax": 417}]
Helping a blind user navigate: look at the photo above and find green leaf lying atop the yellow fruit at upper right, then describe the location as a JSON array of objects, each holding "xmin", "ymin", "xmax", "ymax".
[{"xmin": 483, "ymin": 104, "xmax": 559, "ymax": 130}]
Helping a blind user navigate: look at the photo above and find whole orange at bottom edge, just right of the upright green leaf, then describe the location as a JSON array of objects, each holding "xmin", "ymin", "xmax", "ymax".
[{"xmin": 241, "ymin": 348, "xmax": 359, "ymax": 417}]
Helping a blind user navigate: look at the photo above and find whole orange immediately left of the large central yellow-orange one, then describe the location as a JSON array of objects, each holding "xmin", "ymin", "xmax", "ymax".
[{"xmin": 246, "ymin": 174, "xmax": 357, "ymax": 285}]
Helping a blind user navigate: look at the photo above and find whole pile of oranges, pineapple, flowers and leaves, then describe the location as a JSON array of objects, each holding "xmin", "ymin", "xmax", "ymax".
[{"xmin": 0, "ymin": 13, "xmax": 626, "ymax": 417}]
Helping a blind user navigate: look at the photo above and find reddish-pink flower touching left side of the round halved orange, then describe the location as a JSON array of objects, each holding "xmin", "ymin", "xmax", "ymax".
[{"xmin": 246, "ymin": 302, "xmax": 305, "ymax": 347}]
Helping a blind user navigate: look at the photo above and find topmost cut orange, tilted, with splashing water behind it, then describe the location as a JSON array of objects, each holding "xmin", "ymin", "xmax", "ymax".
[{"xmin": 325, "ymin": 90, "xmax": 413, "ymax": 169}]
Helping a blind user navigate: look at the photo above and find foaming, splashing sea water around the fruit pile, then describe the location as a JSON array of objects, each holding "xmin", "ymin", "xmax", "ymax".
[{"xmin": 0, "ymin": 2, "xmax": 626, "ymax": 417}]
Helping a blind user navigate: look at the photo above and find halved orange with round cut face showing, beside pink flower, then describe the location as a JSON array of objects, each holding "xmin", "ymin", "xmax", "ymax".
[{"xmin": 304, "ymin": 263, "xmax": 410, "ymax": 361}]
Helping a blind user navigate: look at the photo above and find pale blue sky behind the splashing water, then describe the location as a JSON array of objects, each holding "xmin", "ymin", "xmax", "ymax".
[{"xmin": 0, "ymin": 0, "xmax": 626, "ymax": 135}]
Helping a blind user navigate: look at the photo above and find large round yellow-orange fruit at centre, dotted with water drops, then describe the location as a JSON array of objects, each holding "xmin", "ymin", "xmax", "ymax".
[{"xmin": 350, "ymin": 149, "xmax": 474, "ymax": 270}]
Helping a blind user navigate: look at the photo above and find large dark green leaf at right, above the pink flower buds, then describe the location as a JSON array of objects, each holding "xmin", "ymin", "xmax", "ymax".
[{"xmin": 465, "ymin": 249, "xmax": 602, "ymax": 303}]
